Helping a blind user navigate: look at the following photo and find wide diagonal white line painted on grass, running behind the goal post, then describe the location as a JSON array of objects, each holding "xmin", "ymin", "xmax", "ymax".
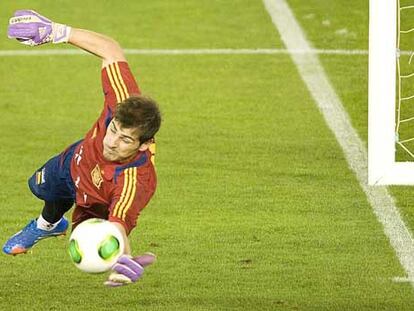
[{"xmin": 263, "ymin": 0, "xmax": 414, "ymax": 286}]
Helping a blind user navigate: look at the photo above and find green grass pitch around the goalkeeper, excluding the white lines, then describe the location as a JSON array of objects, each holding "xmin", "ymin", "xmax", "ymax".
[{"xmin": 0, "ymin": 0, "xmax": 414, "ymax": 310}]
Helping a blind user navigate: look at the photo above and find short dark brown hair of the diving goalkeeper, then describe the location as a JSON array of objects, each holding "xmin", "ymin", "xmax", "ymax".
[{"xmin": 114, "ymin": 95, "xmax": 161, "ymax": 144}]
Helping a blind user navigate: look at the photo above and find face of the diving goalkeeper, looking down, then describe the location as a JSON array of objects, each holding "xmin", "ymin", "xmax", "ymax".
[{"xmin": 103, "ymin": 119, "xmax": 147, "ymax": 162}]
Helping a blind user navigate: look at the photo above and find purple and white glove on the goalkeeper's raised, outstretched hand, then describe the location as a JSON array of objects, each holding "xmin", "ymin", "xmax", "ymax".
[{"xmin": 7, "ymin": 10, "xmax": 71, "ymax": 46}]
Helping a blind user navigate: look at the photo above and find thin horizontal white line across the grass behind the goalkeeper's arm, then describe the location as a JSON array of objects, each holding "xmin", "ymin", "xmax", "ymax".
[{"xmin": 0, "ymin": 49, "xmax": 368, "ymax": 57}]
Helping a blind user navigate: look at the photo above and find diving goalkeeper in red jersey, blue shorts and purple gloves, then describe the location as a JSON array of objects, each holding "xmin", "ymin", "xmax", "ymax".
[{"xmin": 3, "ymin": 10, "xmax": 161, "ymax": 286}]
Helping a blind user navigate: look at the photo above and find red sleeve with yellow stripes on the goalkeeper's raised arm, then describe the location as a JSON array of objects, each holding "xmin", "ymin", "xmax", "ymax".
[{"xmin": 101, "ymin": 62, "xmax": 141, "ymax": 111}]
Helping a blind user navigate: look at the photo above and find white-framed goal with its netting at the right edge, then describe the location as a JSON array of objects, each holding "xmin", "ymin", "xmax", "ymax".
[{"xmin": 368, "ymin": 0, "xmax": 414, "ymax": 185}]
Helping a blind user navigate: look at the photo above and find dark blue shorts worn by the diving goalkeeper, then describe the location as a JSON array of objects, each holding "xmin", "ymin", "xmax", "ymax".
[{"xmin": 29, "ymin": 141, "xmax": 81, "ymax": 202}]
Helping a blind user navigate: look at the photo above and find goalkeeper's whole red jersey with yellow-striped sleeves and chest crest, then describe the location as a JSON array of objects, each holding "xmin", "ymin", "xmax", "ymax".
[{"xmin": 70, "ymin": 62, "xmax": 156, "ymax": 234}]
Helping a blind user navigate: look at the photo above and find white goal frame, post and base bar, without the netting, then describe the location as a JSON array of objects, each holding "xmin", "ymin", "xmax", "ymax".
[{"xmin": 368, "ymin": 0, "xmax": 414, "ymax": 185}]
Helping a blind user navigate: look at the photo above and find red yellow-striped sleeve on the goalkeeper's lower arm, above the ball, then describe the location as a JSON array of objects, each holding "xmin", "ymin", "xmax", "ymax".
[{"xmin": 108, "ymin": 165, "xmax": 156, "ymax": 234}]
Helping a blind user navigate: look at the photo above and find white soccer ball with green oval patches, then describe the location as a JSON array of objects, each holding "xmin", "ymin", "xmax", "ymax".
[{"xmin": 69, "ymin": 218, "xmax": 125, "ymax": 273}]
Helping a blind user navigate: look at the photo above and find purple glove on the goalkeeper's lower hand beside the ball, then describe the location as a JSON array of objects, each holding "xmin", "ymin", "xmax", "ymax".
[{"xmin": 104, "ymin": 253, "xmax": 155, "ymax": 287}]
